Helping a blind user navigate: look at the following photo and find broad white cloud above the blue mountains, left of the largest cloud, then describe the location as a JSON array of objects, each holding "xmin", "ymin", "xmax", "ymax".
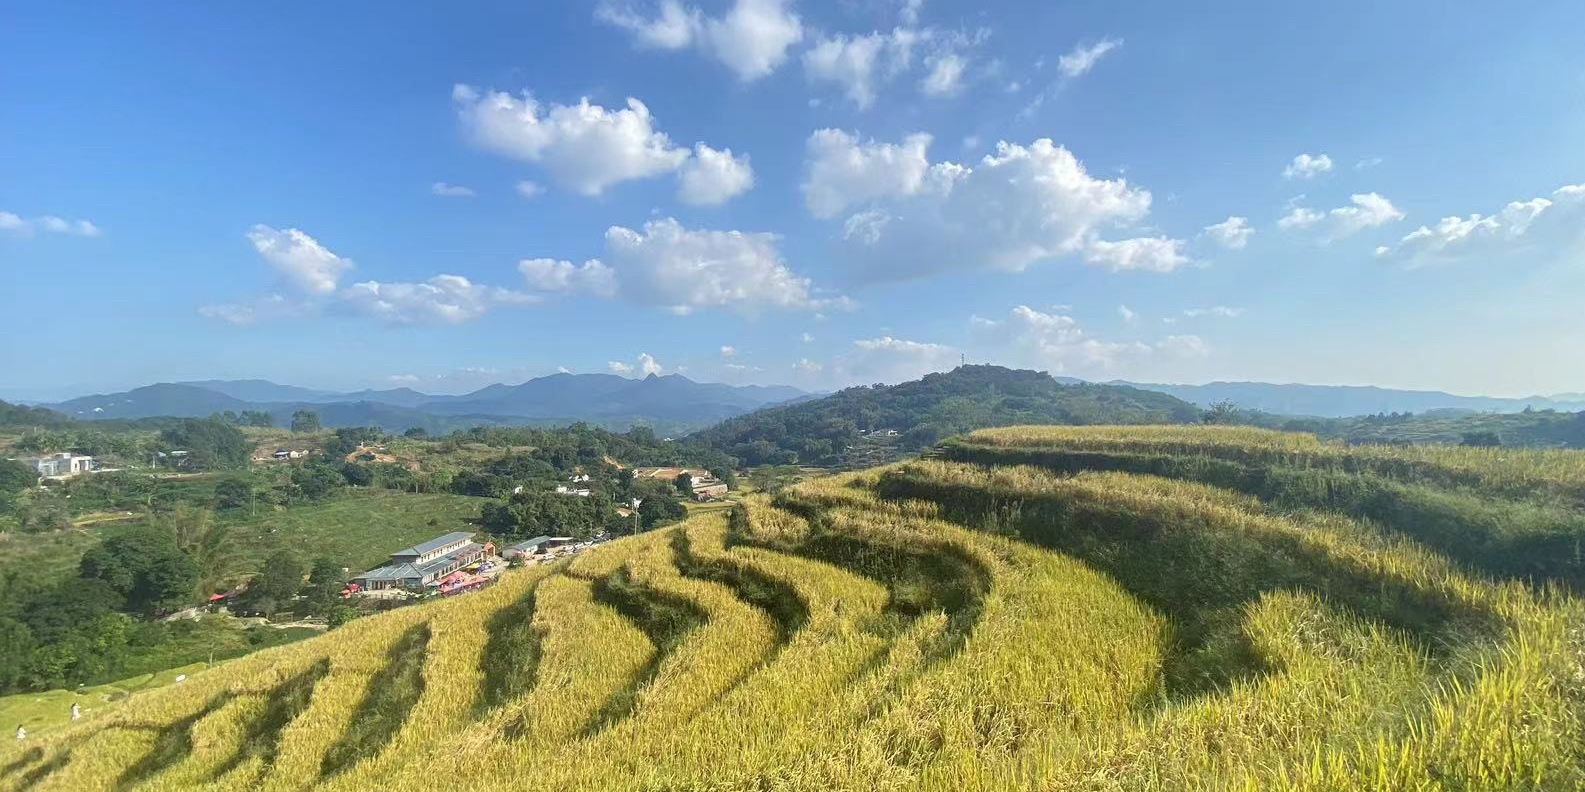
[{"xmin": 605, "ymin": 217, "xmax": 851, "ymax": 314}]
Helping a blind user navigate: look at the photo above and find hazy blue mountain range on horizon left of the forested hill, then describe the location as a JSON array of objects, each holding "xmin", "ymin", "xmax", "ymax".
[{"xmin": 44, "ymin": 374, "xmax": 808, "ymax": 432}]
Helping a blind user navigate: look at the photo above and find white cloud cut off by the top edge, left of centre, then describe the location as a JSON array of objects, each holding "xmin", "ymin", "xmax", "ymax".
[{"xmin": 594, "ymin": 0, "xmax": 804, "ymax": 82}]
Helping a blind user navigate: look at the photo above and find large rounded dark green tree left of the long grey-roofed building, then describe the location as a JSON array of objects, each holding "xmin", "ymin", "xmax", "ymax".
[{"xmin": 78, "ymin": 526, "xmax": 198, "ymax": 616}]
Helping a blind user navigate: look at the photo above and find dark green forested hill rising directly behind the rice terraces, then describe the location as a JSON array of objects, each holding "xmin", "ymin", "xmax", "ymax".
[{"xmin": 691, "ymin": 366, "xmax": 1200, "ymax": 466}]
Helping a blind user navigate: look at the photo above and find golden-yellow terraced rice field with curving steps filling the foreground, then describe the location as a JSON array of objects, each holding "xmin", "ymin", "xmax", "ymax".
[{"xmin": 0, "ymin": 428, "xmax": 1585, "ymax": 792}]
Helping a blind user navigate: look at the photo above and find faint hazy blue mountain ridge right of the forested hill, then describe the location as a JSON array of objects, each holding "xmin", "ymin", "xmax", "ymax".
[{"xmin": 1096, "ymin": 380, "xmax": 1585, "ymax": 418}]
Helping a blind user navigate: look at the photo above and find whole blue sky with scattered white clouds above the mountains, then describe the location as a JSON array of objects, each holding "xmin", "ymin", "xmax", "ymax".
[{"xmin": 0, "ymin": 0, "xmax": 1585, "ymax": 399}]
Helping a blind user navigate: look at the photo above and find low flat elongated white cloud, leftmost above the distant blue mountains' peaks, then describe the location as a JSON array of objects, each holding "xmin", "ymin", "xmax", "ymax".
[{"xmin": 338, "ymin": 276, "xmax": 539, "ymax": 325}]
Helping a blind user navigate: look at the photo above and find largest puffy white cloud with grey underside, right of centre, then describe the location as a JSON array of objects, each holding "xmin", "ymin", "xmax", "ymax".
[{"xmin": 804, "ymin": 130, "xmax": 1187, "ymax": 279}]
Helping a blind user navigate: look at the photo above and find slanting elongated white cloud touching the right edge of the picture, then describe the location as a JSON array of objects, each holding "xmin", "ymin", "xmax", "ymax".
[{"xmin": 1376, "ymin": 184, "xmax": 1585, "ymax": 263}]
